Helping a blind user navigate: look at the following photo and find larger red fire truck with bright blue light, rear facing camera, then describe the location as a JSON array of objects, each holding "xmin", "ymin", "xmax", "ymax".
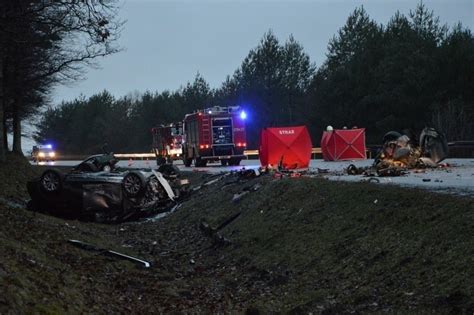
[{"xmin": 183, "ymin": 106, "xmax": 247, "ymax": 166}]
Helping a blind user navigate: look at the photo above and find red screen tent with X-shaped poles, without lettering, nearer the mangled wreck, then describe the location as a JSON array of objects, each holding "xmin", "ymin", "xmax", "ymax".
[{"xmin": 321, "ymin": 128, "xmax": 367, "ymax": 161}]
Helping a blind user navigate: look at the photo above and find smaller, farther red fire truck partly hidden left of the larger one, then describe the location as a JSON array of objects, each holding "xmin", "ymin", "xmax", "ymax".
[{"xmin": 151, "ymin": 122, "xmax": 183, "ymax": 165}]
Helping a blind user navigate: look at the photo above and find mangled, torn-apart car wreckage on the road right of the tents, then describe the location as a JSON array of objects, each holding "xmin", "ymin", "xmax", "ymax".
[{"xmin": 373, "ymin": 127, "xmax": 448, "ymax": 176}]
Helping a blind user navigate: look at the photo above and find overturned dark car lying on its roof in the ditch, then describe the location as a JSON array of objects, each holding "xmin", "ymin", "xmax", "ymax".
[{"xmin": 27, "ymin": 162, "xmax": 189, "ymax": 222}]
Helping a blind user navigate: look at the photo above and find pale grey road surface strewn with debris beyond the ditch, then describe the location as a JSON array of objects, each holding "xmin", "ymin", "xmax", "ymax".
[{"xmin": 32, "ymin": 159, "xmax": 474, "ymax": 197}]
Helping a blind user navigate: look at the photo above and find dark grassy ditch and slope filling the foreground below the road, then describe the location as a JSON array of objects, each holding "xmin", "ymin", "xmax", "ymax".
[{"xmin": 0, "ymin": 157, "xmax": 474, "ymax": 314}]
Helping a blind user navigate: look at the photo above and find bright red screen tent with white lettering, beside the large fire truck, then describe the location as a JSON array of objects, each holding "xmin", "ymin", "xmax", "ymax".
[{"xmin": 259, "ymin": 126, "xmax": 312, "ymax": 169}]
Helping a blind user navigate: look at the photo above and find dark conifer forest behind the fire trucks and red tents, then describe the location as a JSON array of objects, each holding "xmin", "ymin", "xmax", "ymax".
[{"xmin": 35, "ymin": 3, "xmax": 474, "ymax": 153}]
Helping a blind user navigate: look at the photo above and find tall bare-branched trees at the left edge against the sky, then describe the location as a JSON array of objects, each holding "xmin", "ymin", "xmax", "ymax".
[{"xmin": 0, "ymin": 0, "xmax": 123, "ymax": 161}]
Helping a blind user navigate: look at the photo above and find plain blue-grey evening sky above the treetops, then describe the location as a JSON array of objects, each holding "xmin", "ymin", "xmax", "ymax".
[{"xmin": 52, "ymin": 0, "xmax": 474, "ymax": 104}]
